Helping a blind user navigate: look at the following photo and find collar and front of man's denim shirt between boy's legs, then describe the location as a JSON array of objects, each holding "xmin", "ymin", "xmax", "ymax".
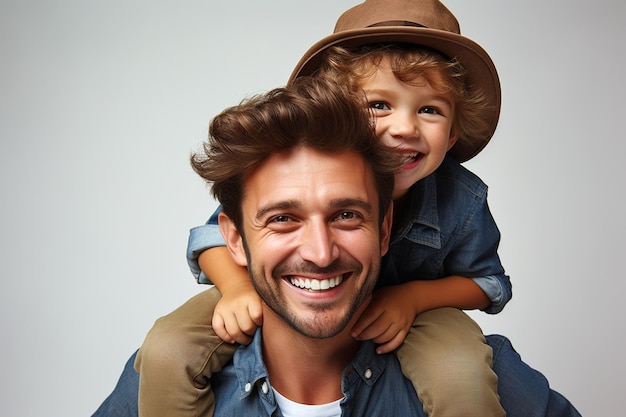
[{"xmin": 211, "ymin": 329, "xmax": 426, "ymax": 417}]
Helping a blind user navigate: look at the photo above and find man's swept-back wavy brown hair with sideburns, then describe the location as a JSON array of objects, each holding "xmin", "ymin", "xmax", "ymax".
[{"xmin": 191, "ymin": 77, "xmax": 399, "ymax": 230}]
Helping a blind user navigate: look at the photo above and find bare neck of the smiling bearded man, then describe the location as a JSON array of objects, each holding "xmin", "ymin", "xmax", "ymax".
[{"xmin": 262, "ymin": 309, "xmax": 360, "ymax": 404}]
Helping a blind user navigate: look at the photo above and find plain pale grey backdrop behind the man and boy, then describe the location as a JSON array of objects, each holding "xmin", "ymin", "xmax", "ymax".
[{"xmin": 0, "ymin": 0, "xmax": 626, "ymax": 417}]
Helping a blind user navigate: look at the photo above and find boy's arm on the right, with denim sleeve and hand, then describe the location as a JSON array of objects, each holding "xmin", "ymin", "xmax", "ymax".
[{"xmin": 353, "ymin": 169, "xmax": 512, "ymax": 353}]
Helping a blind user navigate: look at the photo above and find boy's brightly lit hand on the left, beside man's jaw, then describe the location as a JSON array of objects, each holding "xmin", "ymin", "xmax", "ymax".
[{"xmin": 213, "ymin": 282, "xmax": 263, "ymax": 345}]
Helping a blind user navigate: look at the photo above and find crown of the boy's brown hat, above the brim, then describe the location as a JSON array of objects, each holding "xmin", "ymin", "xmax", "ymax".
[{"xmin": 334, "ymin": 0, "xmax": 461, "ymax": 34}]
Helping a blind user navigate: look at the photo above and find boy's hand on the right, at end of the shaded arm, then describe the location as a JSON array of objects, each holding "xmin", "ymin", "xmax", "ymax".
[{"xmin": 352, "ymin": 285, "xmax": 417, "ymax": 353}]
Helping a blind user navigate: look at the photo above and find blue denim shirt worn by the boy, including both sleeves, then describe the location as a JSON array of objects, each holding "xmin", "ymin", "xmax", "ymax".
[{"xmin": 187, "ymin": 157, "xmax": 513, "ymax": 314}]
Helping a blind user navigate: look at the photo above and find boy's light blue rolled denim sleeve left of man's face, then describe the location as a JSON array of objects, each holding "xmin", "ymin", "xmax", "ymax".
[{"xmin": 187, "ymin": 206, "xmax": 226, "ymax": 284}]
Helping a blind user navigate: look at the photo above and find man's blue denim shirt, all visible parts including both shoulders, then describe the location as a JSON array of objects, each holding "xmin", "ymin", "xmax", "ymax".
[{"xmin": 92, "ymin": 335, "xmax": 580, "ymax": 417}]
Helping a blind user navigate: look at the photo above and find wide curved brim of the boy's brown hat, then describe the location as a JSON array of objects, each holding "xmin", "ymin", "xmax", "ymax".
[{"xmin": 289, "ymin": 26, "xmax": 501, "ymax": 162}]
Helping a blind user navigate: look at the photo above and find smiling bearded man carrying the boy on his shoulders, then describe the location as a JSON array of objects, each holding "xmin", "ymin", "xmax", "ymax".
[{"xmin": 95, "ymin": 77, "xmax": 578, "ymax": 417}]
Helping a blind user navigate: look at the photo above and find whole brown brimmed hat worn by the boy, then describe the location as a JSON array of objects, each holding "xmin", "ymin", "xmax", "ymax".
[{"xmin": 289, "ymin": 0, "xmax": 500, "ymax": 162}]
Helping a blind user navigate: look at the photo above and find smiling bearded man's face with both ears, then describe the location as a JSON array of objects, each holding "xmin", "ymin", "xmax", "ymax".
[{"xmin": 220, "ymin": 147, "xmax": 391, "ymax": 338}]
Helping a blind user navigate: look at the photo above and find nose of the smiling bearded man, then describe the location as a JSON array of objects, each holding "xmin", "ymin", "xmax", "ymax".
[{"xmin": 300, "ymin": 220, "xmax": 339, "ymax": 267}]
